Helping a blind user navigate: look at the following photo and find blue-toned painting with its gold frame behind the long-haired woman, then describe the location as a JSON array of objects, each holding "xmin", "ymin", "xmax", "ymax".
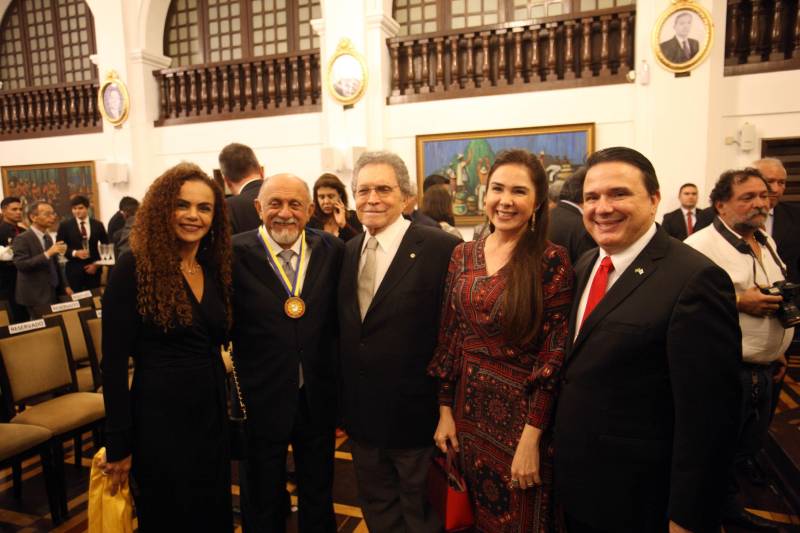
[{"xmin": 417, "ymin": 123, "xmax": 594, "ymax": 226}]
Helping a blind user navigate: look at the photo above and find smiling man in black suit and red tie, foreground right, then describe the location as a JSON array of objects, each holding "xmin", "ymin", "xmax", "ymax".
[{"xmin": 554, "ymin": 148, "xmax": 742, "ymax": 533}]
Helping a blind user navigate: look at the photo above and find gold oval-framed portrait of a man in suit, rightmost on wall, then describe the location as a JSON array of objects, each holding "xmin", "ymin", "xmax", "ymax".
[{"xmin": 652, "ymin": 0, "xmax": 714, "ymax": 73}]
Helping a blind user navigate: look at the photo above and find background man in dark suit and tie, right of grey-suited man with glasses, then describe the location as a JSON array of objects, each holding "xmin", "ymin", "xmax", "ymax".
[{"xmin": 56, "ymin": 195, "xmax": 108, "ymax": 292}]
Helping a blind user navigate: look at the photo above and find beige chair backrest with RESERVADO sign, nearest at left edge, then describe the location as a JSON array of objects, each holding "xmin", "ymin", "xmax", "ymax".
[{"xmin": 0, "ymin": 316, "xmax": 76, "ymax": 413}]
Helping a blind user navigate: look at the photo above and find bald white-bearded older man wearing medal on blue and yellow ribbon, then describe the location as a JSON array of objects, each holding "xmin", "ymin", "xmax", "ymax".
[{"xmin": 232, "ymin": 174, "xmax": 344, "ymax": 533}]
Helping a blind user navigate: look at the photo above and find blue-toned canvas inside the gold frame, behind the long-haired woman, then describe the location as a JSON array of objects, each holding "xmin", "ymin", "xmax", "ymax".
[{"xmin": 417, "ymin": 127, "xmax": 591, "ymax": 216}]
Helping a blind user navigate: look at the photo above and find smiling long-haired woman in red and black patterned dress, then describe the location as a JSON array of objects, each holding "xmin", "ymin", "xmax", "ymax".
[{"xmin": 428, "ymin": 150, "xmax": 573, "ymax": 533}]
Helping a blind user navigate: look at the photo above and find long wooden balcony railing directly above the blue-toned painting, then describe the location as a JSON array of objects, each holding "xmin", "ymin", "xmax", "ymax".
[{"xmin": 387, "ymin": 6, "xmax": 635, "ymax": 104}]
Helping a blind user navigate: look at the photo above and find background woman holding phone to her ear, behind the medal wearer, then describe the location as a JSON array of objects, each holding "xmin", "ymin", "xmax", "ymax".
[{"xmin": 307, "ymin": 172, "xmax": 364, "ymax": 242}]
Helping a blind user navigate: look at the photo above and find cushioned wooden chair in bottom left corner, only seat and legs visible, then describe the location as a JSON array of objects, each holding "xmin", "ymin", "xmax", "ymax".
[{"xmin": 0, "ymin": 424, "xmax": 66, "ymax": 524}]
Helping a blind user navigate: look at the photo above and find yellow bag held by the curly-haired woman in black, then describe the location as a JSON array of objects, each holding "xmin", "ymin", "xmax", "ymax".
[{"xmin": 89, "ymin": 448, "xmax": 133, "ymax": 533}]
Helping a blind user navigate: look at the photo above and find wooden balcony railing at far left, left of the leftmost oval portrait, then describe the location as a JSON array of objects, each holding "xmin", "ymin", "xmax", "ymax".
[{"xmin": 0, "ymin": 81, "xmax": 103, "ymax": 141}]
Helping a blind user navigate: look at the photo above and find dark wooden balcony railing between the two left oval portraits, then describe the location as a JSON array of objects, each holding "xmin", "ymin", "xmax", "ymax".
[{"xmin": 153, "ymin": 50, "xmax": 321, "ymax": 126}]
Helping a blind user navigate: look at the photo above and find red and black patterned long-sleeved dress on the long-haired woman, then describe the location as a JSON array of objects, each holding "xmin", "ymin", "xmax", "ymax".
[{"xmin": 428, "ymin": 239, "xmax": 573, "ymax": 533}]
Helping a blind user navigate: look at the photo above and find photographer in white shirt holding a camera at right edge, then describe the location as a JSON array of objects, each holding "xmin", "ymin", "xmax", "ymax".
[{"xmin": 685, "ymin": 168, "xmax": 798, "ymax": 531}]
